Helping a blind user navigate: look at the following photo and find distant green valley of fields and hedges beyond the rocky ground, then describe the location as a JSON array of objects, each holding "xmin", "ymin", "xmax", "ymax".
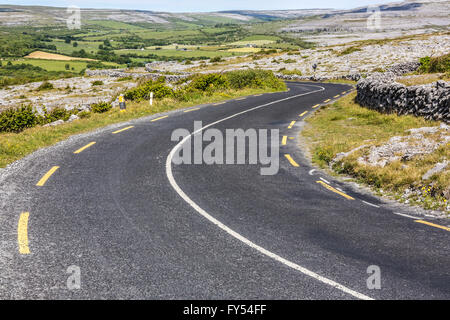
[{"xmin": 0, "ymin": 14, "xmax": 312, "ymax": 83}]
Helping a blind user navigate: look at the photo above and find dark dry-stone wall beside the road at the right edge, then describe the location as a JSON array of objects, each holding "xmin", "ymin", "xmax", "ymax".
[{"xmin": 356, "ymin": 70, "xmax": 450, "ymax": 123}]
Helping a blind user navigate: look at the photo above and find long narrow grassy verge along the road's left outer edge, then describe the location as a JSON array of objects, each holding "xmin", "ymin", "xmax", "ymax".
[{"xmin": 0, "ymin": 89, "xmax": 282, "ymax": 168}]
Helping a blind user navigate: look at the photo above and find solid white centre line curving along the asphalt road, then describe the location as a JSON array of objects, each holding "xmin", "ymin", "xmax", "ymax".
[{"xmin": 166, "ymin": 86, "xmax": 373, "ymax": 300}]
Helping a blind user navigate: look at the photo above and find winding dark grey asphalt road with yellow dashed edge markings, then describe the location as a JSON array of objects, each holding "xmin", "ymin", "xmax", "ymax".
[{"xmin": 0, "ymin": 83, "xmax": 450, "ymax": 299}]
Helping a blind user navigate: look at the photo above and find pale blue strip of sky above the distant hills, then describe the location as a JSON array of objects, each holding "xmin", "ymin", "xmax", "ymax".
[{"xmin": 0, "ymin": 0, "xmax": 395, "ymax": 12}]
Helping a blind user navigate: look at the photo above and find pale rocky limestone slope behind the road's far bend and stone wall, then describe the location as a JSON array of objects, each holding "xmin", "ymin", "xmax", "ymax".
[{"xmin": 155, "ymin": 34, "xmax": 450, "ymax": 78}]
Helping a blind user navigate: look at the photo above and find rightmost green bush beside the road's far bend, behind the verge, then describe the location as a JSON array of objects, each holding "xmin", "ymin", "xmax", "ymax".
[{"xmin": 225, "ymin": 69, "xmax": 286, "ymax": 90}]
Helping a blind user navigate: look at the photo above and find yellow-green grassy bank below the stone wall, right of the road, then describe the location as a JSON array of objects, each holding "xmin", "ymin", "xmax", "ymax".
[{"xmin": 302, "ymin": 94, "xmax": 450, "ymax": 210}]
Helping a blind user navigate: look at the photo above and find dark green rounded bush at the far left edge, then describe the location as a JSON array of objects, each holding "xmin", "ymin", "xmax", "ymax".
[{"xmin": 0, "ymin": 106, "xmax": 37, "ymax": 132}]
